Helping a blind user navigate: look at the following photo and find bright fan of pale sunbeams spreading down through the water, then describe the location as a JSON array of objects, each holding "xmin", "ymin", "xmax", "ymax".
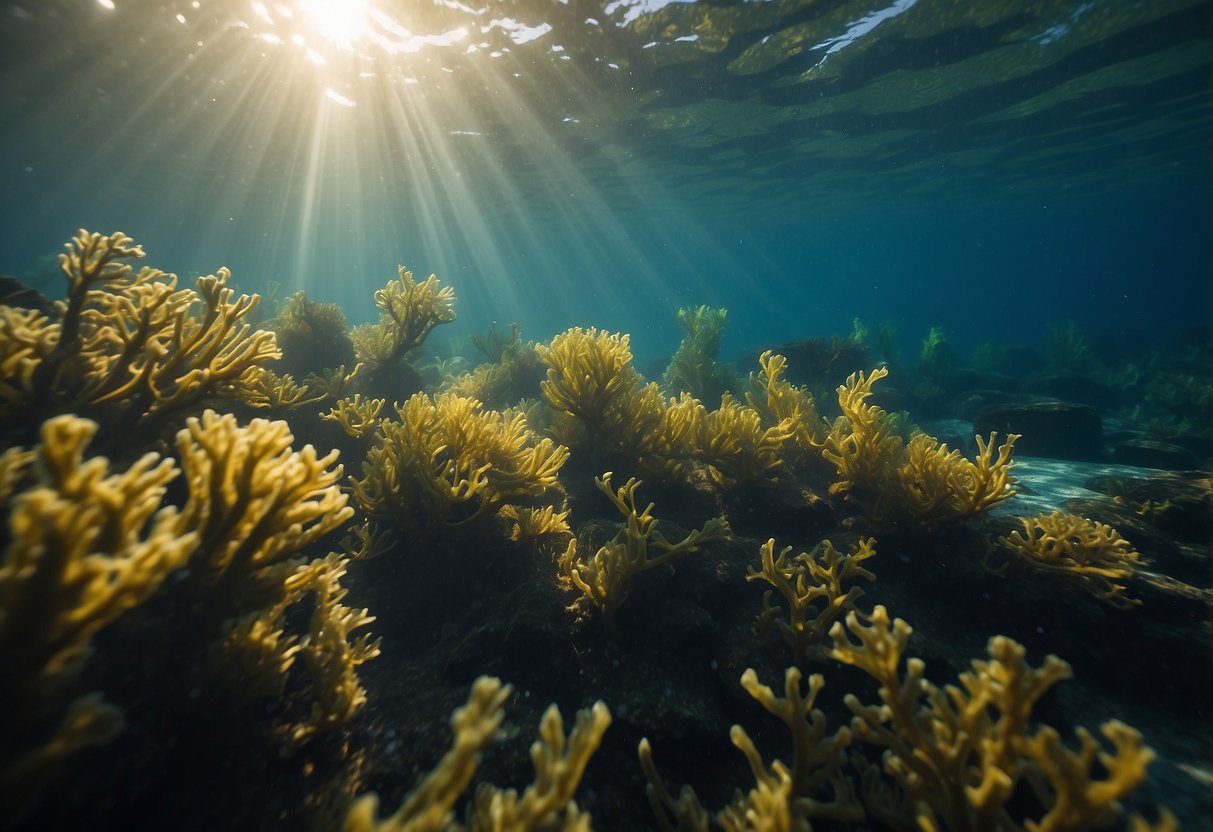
[{"xmin": 144, "ymin": 0, "xmax": 728, "ymax": 344}]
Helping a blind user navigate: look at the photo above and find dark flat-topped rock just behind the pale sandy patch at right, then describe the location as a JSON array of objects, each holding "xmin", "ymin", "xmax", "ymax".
[{"xmin": 973, "ymin": 401, "xmax": 1104, "ymax": 461}]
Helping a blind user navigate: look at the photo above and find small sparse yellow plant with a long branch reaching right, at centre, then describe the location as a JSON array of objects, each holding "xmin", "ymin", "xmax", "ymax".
[{"xmin": 558, "ymin": 472, "xmax": 731, "ymax": 627}]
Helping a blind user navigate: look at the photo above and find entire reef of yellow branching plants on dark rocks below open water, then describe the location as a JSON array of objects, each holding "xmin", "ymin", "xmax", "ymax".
[{"xmin": 0, "ymin": 232, "xmax": 1213, "ymax": 832}]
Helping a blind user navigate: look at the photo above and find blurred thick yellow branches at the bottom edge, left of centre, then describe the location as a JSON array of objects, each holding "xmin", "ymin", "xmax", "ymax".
[{"xmin": 342, "ymin": 677, "xmax": 610, "ymax": 832}]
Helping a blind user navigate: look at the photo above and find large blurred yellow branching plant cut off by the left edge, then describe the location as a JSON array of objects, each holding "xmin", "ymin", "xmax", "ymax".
[{"xmin": 0, "ymin": 416, "xmax": 199, "ymax": 820}]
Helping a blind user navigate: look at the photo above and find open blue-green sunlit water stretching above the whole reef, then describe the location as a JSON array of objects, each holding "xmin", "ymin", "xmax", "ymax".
[{"xmin": 0, "ymin": 0, "xmax": 1211, "ymax": 355}]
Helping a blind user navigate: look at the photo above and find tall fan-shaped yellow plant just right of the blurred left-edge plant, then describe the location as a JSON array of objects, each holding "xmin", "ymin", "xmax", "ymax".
[{"xmin": 166, "ymin": 411, "xmax": 378, "ymax": 746}]
